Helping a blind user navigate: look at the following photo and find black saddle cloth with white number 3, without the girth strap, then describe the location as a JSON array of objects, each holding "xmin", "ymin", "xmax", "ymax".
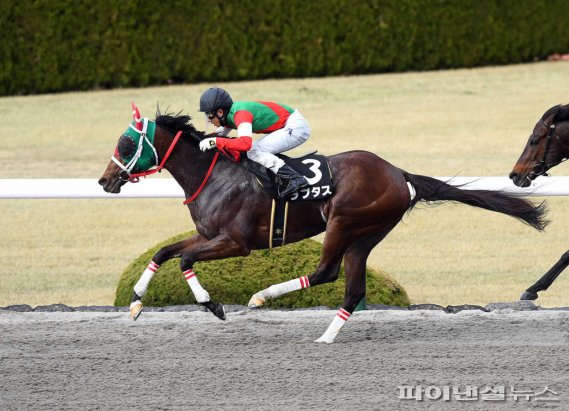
[{"xmin": 240, "ymin": 151, "xmax": 334, "ymax": 201}]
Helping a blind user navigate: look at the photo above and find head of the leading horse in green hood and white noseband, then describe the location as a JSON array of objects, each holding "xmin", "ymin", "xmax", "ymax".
[{"xmin": 99, "ymin": 103, "xmax": 158, "ymax": 194}]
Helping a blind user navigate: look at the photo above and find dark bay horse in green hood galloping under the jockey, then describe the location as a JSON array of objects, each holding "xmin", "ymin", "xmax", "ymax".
[{"xmin": 99, "ymin": 105, "xmax": 547, "ymax": 343}]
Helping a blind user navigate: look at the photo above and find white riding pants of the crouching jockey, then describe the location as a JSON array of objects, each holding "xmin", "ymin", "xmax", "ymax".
[{"xmin": 247, "ymin": 110, "xmax": 310, "ymax": 174}]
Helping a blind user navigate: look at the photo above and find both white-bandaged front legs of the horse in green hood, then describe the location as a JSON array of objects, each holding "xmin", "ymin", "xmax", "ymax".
[{"xmin": 130, "ymin": 234, "xmax": 250, "ymax": 320}]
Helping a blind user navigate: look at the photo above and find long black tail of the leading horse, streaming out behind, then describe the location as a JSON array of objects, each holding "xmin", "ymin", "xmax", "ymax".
[{"xmin": 405, "ymin": 173, "xmax": 549, "ymax": 231}]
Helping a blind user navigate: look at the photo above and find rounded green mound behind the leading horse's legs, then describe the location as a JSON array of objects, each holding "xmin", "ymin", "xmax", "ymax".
[{"xmin": 115, "ymin": 231, "xmax": 409, "ymax": 308}]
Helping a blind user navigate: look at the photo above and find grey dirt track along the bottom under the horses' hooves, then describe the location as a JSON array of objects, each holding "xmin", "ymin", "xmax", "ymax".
[{"xmin": 0, "ymin": 309, "xmax": 569, "ymax": 410}]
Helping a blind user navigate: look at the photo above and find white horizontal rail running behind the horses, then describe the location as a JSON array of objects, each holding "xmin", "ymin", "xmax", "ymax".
[{"xmin": 0, "ymin": 177, "xmax": 569, "ymax": 199}]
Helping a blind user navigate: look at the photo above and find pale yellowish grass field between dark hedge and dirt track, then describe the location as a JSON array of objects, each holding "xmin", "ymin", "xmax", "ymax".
[{"xmin": 0, "ymin": 62, "xmax": 569, "ymax": 306}]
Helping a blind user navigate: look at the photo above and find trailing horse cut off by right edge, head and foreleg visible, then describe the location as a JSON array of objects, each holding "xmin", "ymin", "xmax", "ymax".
[{"xmin": 510, "ymin": 104, "xmax": 569, "ymax": 300}]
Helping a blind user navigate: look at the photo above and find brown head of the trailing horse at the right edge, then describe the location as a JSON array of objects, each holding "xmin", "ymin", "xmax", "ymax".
[{"xmin": 510, "ymin": 105, "xmax": 569, "ymax": 187}]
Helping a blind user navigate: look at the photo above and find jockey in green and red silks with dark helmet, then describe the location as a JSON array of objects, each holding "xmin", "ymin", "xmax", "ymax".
[{"xmin": 199, "ymin": 87, "xmax": 310, "ymax": 198}]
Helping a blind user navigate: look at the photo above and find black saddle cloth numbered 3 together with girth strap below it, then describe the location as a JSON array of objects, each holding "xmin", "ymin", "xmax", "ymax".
[{"xmin": 241, "ymin": 152, "xmax": 334, "ymax": 248}]
